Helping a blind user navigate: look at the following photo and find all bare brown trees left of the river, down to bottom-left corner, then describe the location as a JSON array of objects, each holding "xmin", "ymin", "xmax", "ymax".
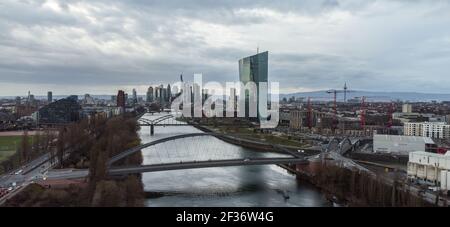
[{"xmin": 6, "ymin": 116, "xmax": 145, "ymax": 207}]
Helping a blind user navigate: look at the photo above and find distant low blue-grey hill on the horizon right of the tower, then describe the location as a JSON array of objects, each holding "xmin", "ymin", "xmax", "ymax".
[{"xmin": 280, "ymin": 91, "xmax": 450, "ymax": 102}]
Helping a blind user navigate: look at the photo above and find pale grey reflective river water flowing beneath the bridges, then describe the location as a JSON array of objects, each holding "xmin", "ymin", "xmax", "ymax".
[{"xmin": 139, "ymin": 115, "xmax": 331, "ymax": 207}]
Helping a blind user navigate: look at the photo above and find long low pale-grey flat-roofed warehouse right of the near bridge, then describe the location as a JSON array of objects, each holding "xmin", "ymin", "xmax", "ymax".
[{"xmin": 373, "ymin": 134, "xmax": 436, "ymax": 155}]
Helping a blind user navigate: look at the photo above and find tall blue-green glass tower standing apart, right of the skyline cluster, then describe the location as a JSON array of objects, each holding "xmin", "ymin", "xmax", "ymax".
[{"xmin": 239, "ymin": 51, "xmax": 269, "ymax": 118}]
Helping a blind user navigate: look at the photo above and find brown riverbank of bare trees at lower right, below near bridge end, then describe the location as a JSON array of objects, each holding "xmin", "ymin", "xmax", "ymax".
[{"xmin": 290, "ymin": 156, "xmax": 436, "ymax": 207}]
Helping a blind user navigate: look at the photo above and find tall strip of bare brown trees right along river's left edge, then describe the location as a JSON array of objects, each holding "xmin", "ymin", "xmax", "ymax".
[{"xmin": 87, "ymin": 117, "xmax": 144, "ymax": 207}]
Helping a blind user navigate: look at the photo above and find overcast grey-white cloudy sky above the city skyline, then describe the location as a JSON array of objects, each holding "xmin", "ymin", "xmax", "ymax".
[{"xmin": 0, "ymin": 0, "xmax": 450, "ymax": 95}]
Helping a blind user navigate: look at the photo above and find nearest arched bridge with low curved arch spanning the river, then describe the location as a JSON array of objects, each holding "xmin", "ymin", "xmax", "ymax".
[{"xmin": 47, "ymin": 133, "xmax": 307, "ymax": 179}]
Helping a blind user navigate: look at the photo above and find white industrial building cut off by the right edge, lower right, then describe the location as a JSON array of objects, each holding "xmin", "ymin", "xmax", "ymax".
[{"xmin": 408, "ymin": 151, "xmax": 450, "ymax": 192}]
